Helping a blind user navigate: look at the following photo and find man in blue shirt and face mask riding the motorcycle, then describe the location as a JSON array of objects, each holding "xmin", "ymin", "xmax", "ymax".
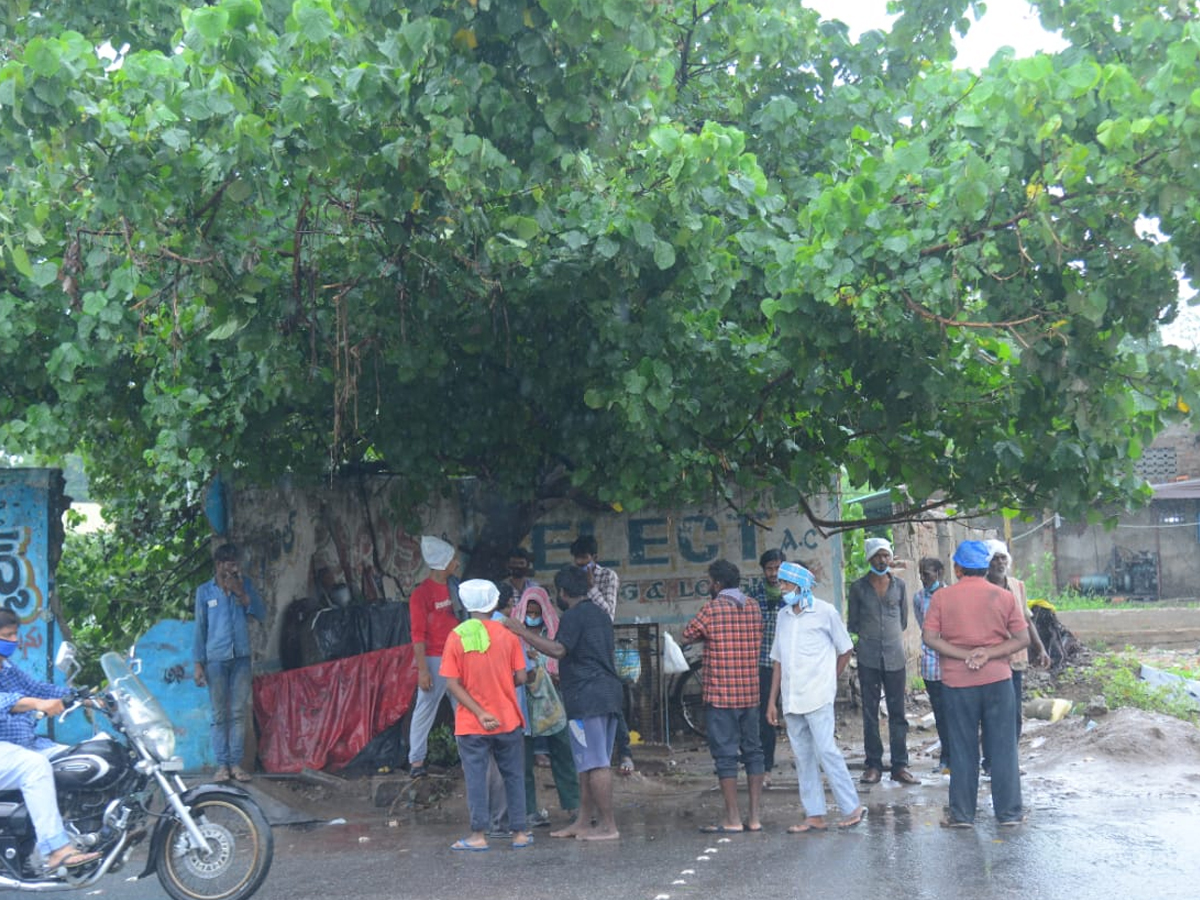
[{"xmin": 0, "ymin": 608, "xmax": 101, "ymax": 872}]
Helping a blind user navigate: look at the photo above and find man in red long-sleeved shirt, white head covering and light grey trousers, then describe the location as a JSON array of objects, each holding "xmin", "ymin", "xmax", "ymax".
[{"xmin": 408, "ymin": 535, "xmax": 458, "ymax": 778}]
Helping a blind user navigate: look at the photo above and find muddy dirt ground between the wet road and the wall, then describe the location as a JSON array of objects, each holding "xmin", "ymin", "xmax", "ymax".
[{"xmin": 246, "ymin": 650, "xmax": 1200, "ymax": 828}]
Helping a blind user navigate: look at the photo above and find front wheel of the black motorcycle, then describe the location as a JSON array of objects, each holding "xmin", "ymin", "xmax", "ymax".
[{"xmin": 156, "ymin": 794, "xmax": 275, "ymax": 900}]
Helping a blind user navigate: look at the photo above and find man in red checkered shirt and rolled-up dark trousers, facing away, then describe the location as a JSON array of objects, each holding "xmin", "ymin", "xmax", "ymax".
[{"xmin": 680, "ymin": 559, "xmax": 763, "ymax": 834}]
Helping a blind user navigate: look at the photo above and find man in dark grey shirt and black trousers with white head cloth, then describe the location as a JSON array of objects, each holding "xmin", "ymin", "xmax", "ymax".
[{"xmin": 846, "ymin": 538, "xmax": 920, "ymax": 785}]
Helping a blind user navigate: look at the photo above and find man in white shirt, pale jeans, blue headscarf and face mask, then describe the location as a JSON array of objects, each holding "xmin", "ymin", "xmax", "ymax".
[{"xmin": 767, "ymin": 563, "xmax": 866, "ymax": 834}]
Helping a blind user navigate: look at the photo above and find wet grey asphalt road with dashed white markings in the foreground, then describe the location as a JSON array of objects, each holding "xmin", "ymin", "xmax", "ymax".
[{"xmin": 103, "ymin": 772, "xmax": 1200, "ymax": 900}]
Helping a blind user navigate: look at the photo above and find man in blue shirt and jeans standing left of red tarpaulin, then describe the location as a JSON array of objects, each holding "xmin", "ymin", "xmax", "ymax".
[{"xmin": 192, "ymin": 544, "xmax": 266, "ymax": 781}]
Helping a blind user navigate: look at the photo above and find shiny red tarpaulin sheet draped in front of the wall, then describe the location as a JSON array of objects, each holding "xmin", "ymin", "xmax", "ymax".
[{"xmin": 254, "ymin": 644, "xmax": 416, "ymax": 772}]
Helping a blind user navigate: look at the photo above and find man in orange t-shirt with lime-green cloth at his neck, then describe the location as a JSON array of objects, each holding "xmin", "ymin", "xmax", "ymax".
[{"xmin": 442, "ymin": 578, "xmax": 533, "ymax": 850}]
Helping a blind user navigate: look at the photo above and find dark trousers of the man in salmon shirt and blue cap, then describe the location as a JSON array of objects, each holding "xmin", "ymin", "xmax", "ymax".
[{"xmin": 942, "ymin": 678, "xmax": 1021, "ymax": 822}]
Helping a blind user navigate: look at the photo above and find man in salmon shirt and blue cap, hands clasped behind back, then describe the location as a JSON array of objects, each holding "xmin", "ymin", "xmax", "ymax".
[{"xmin": 922, "ymin": 541, "xmax": 1030, "ymax": 828}]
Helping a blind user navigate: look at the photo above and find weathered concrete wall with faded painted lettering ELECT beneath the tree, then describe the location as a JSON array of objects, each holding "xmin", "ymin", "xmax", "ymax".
[{"xmin": 222, "ymin": 478, "xmax": 842, "ymax": 671}]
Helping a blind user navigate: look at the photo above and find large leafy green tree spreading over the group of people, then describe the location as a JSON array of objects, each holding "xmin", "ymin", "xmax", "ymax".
[{"xmin": 0, "ymin": 0, "xmax": 1200, "ymax": 566}]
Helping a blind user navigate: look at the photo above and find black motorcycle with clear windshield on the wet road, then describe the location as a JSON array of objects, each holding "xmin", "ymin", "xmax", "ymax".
[{"xmin": 0, "ymin": 643, "xmax": 275, "ymax": 900}]
